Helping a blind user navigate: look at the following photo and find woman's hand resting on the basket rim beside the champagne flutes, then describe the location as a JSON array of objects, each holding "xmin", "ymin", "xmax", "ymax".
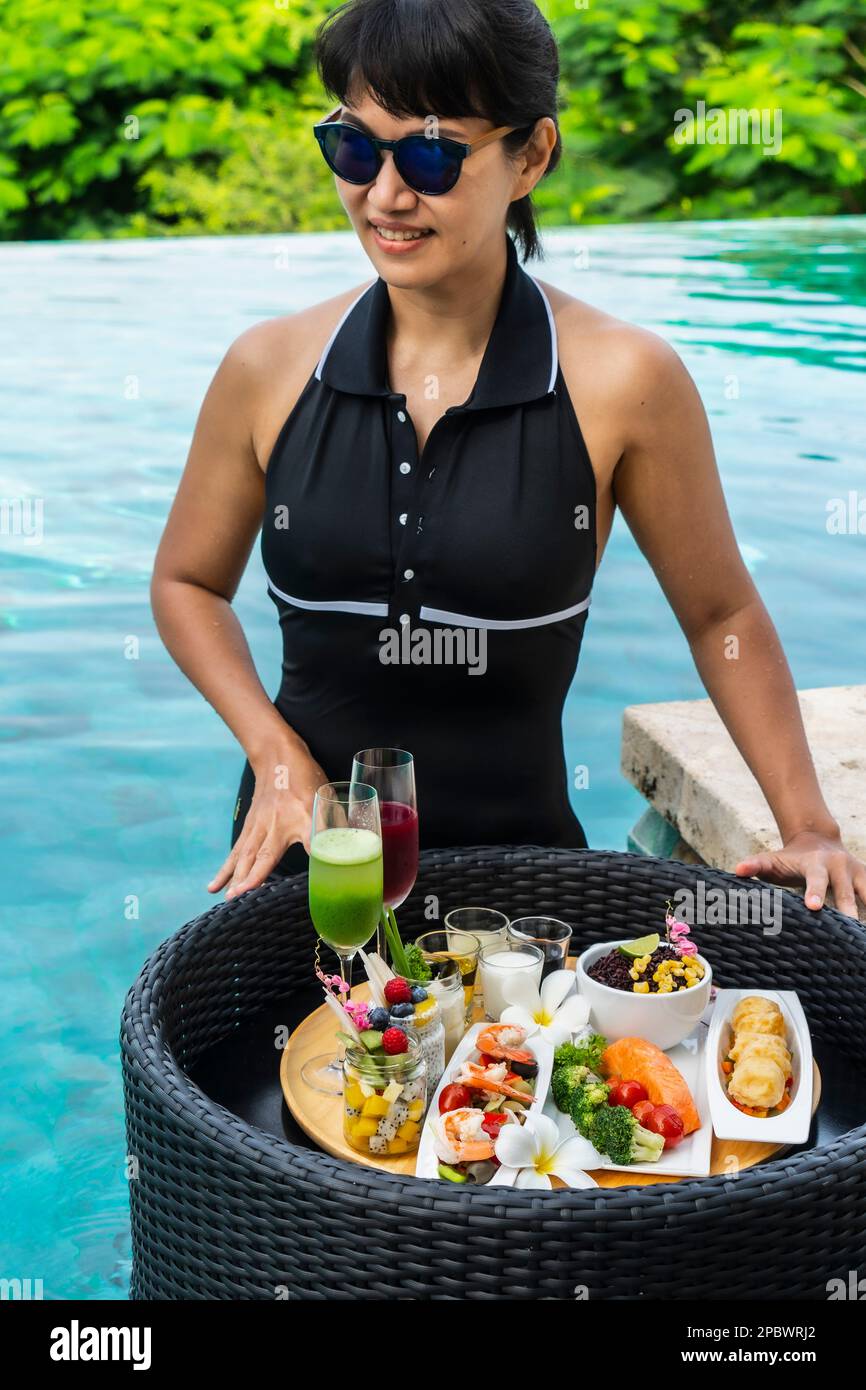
[{"xmin": 207, "ymin": 746, "xmax": 328, "ymax": 899}]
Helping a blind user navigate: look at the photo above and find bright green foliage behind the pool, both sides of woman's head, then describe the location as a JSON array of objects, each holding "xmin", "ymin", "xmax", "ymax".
[{"xmin": 0, "ymin": 0, "xmax": 866, "ymax": 238}]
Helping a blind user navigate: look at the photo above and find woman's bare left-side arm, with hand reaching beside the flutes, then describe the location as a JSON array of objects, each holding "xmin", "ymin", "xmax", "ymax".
[{"xmin": 152, "ymin": 325, "xmax": 327, "ymax": 898}]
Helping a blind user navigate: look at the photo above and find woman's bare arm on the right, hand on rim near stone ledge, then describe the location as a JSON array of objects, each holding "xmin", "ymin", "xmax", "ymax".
[{"xmin": 613, "ymin": 332, "xmax": 866, "ymax": 916}]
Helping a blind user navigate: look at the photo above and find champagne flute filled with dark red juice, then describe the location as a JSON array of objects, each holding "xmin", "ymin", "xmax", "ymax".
[{"xmin": 352, "ymin": 748, "xmax": 418, "ymax": 956}]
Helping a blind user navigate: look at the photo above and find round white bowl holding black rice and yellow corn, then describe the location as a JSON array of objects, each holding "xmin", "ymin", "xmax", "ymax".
[{"xmin": 577, "ymin": 937, "xmax": 713, "ymax": 1052}]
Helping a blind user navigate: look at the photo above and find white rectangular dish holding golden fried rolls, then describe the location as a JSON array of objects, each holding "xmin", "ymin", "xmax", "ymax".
[{"xmin": 705, "ymin": 990, "xmax": 813, "ymax": 1144}]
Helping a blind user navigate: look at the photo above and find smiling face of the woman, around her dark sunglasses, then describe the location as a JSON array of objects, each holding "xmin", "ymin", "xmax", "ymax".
[{"xmin": 336, "ymin": 95, "xmax": 556, "ymax": 288}]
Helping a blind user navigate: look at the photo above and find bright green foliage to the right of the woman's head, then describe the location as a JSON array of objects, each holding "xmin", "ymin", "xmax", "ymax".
[{"xmin": 538, "ymin": 0, "xmax": 866, "ymax": 222}]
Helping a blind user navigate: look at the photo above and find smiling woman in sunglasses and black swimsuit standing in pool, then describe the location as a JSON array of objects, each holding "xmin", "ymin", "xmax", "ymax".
[{"xmin": 153, "ymin": 0, "xmax": 866, "ymax": 913}]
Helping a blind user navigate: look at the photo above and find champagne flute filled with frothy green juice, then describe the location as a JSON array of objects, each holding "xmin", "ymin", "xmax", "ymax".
[{"xmin": 300, "ymin": 781, "xmax": 382, "ymax": 1095}]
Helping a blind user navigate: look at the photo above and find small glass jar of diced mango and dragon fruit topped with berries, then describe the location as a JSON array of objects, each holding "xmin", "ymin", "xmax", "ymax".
[{"xmin": 343, "ymin": 1030, "xmax": 428, "ymax": 1158}]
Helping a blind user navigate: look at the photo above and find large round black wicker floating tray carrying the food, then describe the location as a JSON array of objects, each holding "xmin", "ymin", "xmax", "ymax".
[{"xmin": 121, "ymin": 847, "xmax": 866, "ymax": 1300}]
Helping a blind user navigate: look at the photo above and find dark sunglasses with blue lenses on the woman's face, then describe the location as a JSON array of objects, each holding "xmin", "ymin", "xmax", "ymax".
[{"xmin": 313, "ymin": 107, "xmax": 517, "ymax": 197}]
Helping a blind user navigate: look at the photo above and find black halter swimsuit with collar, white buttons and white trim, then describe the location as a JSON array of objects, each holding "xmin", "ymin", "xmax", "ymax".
[{"xmin": 232, "ymin": 238, "xmax": 595, "ymax": 873}]
